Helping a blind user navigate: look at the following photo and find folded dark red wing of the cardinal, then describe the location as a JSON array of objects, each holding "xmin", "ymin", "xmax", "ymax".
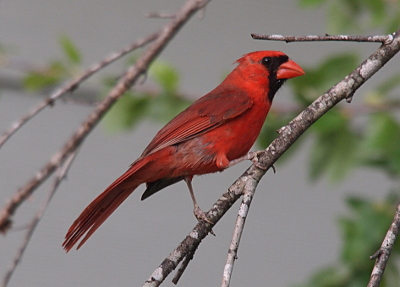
[{"xmin": 142, "ymin": 86, "xmax": 253, "ymax": 156}]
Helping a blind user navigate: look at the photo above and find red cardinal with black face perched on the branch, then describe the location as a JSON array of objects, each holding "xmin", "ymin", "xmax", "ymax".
[{"xmin": 63, "ymin": 51, "xmax": 304, "ymax": 252}]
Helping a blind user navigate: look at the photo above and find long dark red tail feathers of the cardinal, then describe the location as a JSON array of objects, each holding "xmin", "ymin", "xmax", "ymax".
[{"xmin": 62, "ymin": 161, "xmax": 146, "ymax": 252}]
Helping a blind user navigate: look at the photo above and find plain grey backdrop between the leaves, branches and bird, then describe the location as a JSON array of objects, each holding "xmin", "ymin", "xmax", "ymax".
[{"xmin": 0, "ymin": 0, "xmax": 398, "ymax": 286}]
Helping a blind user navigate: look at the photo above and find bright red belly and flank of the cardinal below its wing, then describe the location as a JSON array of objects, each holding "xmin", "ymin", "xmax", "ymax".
[{"xmin": 147, "ymin": 109, "xmax": 266, "ymax": 178}]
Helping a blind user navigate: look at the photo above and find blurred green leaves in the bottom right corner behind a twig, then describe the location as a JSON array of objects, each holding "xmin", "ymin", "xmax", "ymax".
[{"xmin": 295, "ymin": 196, "xmax": 400, "ymax": 287}]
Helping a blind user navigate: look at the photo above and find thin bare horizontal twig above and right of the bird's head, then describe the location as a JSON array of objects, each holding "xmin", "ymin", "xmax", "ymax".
[{"xmin": 251, "ymin": 34, "xmax": 393, "ymax": 44}]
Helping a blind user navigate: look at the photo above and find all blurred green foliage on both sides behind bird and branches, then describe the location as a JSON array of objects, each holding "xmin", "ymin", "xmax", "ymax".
[{"xmin": 6, "ymin": 0, "xmax": 400, "ymax": 287}]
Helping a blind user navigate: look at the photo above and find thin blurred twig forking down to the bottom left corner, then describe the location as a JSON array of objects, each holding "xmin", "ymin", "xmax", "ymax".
[{"xmin": 1, "ymin": 151, "xmax": 78, "ymax": 287}]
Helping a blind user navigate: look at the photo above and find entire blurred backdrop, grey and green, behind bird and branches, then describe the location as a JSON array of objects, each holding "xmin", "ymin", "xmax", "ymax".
[{"xmin": 0, "ymin": 0, "xmax": 400, "ymax": 286}]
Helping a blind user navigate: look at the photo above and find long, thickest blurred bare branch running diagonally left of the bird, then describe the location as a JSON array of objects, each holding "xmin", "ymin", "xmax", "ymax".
[{"xmin": 0, "ymin": 0, "xmax": 211, "ymax": 233}]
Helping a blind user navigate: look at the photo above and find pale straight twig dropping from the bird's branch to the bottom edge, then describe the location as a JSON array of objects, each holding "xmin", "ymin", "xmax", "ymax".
[{"xmin": 221, "ymin": 180, "xmax": 258, "ymax": 287}]
